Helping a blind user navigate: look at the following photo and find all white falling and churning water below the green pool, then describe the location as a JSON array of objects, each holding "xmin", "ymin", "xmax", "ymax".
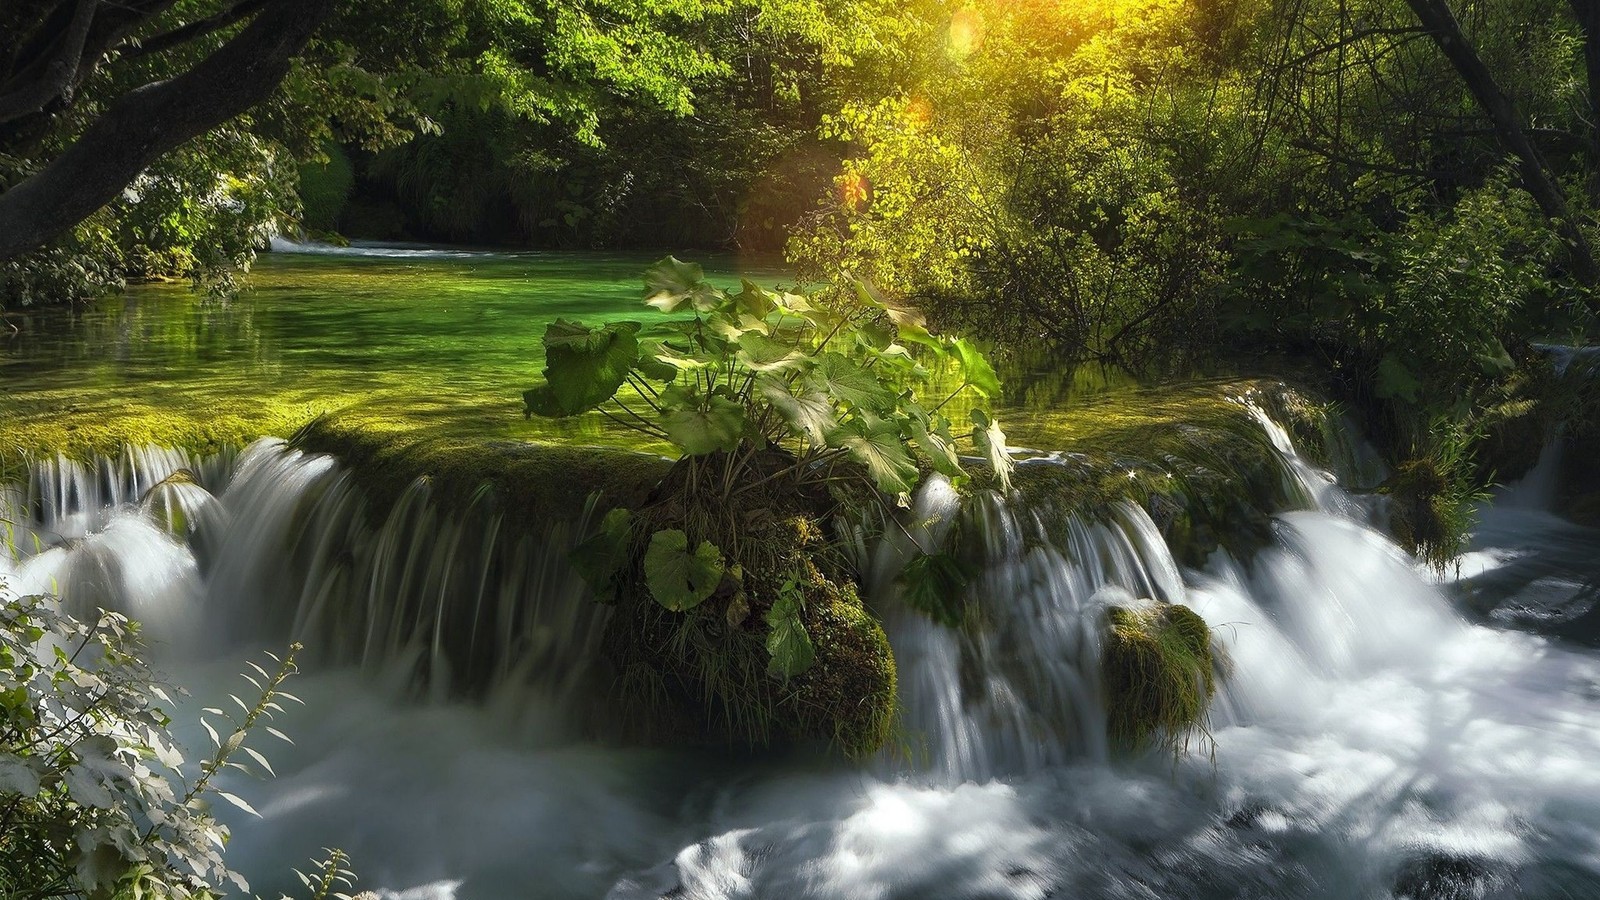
[{"xmin": 0, "ymin": 408, "xmax": 1600, "ymax": 900}]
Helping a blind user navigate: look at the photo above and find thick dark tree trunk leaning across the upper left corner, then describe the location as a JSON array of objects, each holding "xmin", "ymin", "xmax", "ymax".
[{"xmin": 0, "ymin": 0, "xmax": 338, "ymax": 261}]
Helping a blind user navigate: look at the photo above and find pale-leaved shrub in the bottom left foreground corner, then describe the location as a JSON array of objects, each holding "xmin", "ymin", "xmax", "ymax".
[{"xmin": 0, "ymin": 582, "xmax": 308, "ymax": 898}]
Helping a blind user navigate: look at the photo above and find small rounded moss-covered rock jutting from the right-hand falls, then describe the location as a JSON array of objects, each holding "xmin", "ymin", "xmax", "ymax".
[{"xmin": 1101, "ymin": 601, "xmax": 1216, "ymax": 753}]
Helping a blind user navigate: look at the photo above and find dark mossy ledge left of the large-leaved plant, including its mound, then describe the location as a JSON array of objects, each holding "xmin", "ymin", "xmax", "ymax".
[{"xmin": 291, "ymin": 416, "xmax": 896, "ymax": 757}]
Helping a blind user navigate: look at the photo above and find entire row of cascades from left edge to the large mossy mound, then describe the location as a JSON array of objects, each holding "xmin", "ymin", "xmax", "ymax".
[{"xmin": 5, "ymin": 440, "xmax": 605, "ymax": 711}]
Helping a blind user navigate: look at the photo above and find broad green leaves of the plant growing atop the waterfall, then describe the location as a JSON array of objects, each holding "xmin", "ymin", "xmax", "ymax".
[{"xmin": 523, "ymin": 256, "xmax": 1011, "ymax": 679}]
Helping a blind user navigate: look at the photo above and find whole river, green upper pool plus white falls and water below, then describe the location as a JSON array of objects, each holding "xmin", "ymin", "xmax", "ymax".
[{"xmin": 0, "ymin": 241, "xmax": 1600, "ymax": 900}]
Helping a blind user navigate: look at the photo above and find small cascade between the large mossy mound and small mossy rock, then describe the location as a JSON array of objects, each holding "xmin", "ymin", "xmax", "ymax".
[{"xmin": 877, "ymin": 493, "xmax": 1186, "ymax": 783}]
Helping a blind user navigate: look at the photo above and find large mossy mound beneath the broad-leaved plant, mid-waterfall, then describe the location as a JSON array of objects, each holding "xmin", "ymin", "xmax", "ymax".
[{"xmin": 605, "ymin": 466, "xmax": 896, "ymax": 757}]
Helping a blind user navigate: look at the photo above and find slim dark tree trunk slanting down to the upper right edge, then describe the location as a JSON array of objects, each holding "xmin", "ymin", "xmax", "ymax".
[{"xmin": 1406, "ymin": 0, "xmax": 1600, "ymax": 288}]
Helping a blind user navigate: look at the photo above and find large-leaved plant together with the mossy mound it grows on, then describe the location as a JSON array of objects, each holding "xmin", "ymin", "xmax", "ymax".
[{"xmin": 523, "ymin": 258, "xmax": 1011, "ymax": 753}]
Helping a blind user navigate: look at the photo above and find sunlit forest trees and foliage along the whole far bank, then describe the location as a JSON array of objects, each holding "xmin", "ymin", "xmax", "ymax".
[{"xmin": 0, "ymin": 0, "xmax": 1600, "ymax": 422}]
